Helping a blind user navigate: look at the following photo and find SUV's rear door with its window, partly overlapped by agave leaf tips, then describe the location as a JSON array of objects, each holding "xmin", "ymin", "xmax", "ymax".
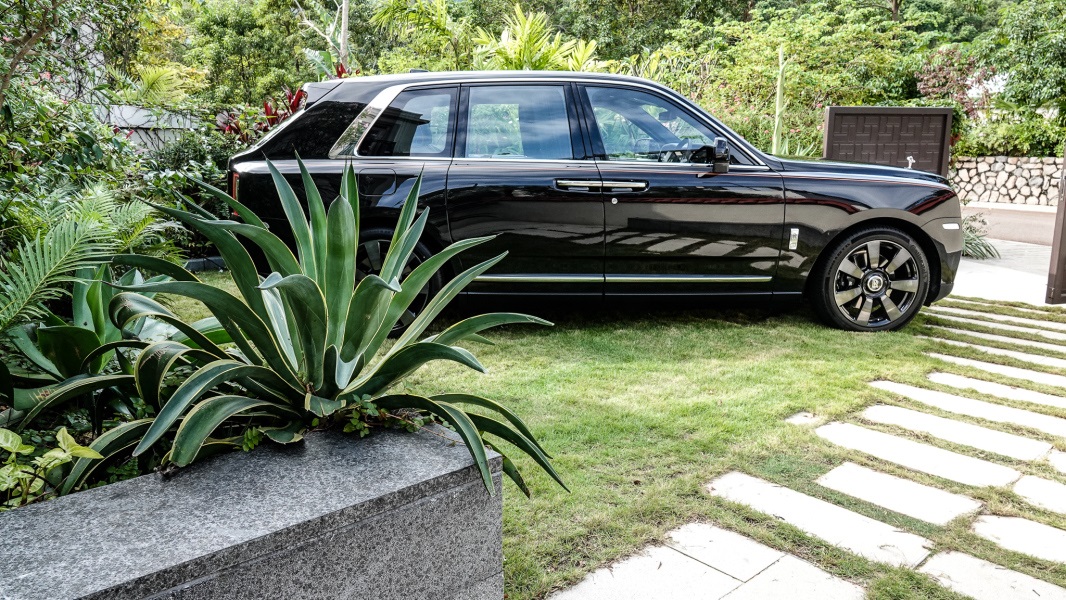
[{"xmin": 448, "ymin": 81, "xmax": 603, "ymax": 294}]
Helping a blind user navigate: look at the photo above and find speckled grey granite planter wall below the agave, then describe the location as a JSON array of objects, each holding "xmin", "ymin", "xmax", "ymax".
[{"xmin": 0, "ymin": 432, "xmax": 503, "ymax": 600}]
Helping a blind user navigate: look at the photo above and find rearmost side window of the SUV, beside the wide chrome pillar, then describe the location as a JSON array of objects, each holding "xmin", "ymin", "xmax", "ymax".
[{"xmin": 358, "ymin": 88, "xmax": 455, "ymax": 157}]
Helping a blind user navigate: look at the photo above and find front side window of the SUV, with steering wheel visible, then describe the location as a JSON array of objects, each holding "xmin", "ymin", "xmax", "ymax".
[{"xmin": 585, "ymin": 86, "xmax": 714, "ymax": 162}]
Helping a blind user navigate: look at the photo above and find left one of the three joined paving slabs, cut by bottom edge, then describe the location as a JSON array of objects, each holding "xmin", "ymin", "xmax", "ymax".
[{"xmin": 551, "ymin": 546, "xmax": 741, "ymax": 600}]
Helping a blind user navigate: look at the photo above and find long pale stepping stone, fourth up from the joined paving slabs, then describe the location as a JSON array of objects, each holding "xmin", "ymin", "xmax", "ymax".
[{"xmin": 862, "ymin": 398, "xmax": 1051, "ymax": 460}]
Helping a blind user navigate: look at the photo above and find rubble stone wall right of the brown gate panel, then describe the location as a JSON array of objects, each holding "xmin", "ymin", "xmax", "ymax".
[{"xmin": 948, "ymin": 157, "xmax": 1064, "ymax": 207}]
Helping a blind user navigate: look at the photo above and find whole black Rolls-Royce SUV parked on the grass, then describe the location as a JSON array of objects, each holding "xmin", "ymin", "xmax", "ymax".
[{"xmin": 229, "ymin": 71, "xmax": 963, "ymax": 330}]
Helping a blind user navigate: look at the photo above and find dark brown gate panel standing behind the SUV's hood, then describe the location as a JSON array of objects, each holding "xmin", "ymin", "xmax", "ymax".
[{"xmin": 822, "ymin": 107, "xmax": 952, "ymax": 177}]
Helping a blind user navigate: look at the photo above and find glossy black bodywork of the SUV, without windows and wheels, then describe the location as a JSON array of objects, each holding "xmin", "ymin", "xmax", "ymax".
[{"xmin": 230, "ymin": 72, "xmax": 962, "ymax": 302}]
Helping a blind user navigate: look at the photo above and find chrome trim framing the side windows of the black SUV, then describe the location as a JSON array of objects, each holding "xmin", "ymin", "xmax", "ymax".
[{"xmin": 329, "ymin": 78, "xmax": 770, "ymax": 166}]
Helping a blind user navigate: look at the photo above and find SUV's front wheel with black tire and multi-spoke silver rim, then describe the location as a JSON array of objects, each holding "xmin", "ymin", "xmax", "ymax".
[{"xmin": 810, "ymin": 227, "xmax": 930, "ymax": 331}]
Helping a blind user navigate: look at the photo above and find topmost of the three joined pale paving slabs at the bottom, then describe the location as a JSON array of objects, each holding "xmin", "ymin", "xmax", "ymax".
[{"xmin": 666, "ymin": 523, "xmax": 785, "ymax": 581}]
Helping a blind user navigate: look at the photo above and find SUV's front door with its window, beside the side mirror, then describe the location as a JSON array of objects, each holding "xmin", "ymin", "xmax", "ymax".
[{"xmin": 580, "ymin": 84, "xmax": 785, "ymax": 294}]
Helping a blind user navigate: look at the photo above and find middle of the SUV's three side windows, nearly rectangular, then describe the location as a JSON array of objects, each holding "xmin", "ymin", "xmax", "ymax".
[{"xmin": 465, "ymin": 85, "xmax": 574, "ymax": 159}]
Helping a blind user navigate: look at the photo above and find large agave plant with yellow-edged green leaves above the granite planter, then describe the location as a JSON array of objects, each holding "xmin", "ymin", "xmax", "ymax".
[{"xmin": 62, "ymin": 161, "xmax": 565, "ymax": 493}]
